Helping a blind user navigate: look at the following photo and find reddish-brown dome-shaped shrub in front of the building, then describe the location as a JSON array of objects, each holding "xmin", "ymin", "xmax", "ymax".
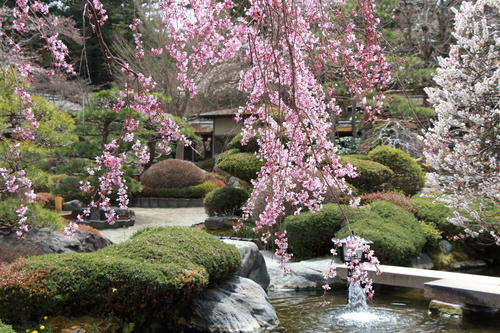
[{"xmin": 141, "ymin": 159, "xmax": 205, "ymax": 189}]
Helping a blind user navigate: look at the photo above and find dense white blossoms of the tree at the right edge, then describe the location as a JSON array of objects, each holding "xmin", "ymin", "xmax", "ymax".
[{"xmin": 424, "ymin": 0, "xmax": 500, "ymax": 245}]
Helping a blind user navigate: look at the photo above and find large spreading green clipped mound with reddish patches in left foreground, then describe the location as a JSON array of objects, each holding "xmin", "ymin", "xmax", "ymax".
[{"xmin": 0, "ymin": 227, "xmax": 240, "ymax": 322}]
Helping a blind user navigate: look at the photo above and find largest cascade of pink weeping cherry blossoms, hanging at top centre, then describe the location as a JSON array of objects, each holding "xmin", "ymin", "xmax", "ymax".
[{"xmin": 161, "ymin": 0, "xmax": 390, "ymax": 296}]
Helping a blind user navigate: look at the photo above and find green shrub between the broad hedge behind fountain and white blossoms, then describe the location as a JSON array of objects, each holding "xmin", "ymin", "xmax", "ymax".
[{"xmin": 410, "ymin": 196, "xmax": 462, "ymax": 237}]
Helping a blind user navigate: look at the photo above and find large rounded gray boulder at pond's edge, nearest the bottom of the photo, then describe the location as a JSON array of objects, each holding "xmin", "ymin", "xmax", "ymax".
[{"xmin": 186, "ymin": 276, "xmax": 278, "ymax": 333}]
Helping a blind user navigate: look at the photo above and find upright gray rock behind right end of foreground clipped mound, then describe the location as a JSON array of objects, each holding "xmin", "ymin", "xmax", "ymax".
[{"xmin": 223, "ymin": 239, "xmax": 270, "ymax": 289}]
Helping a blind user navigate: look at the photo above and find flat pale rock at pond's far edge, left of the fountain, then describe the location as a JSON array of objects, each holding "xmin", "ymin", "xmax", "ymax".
[{"xmin": 261, "ymin": 251, "xmax": 345, "ymax": 290}]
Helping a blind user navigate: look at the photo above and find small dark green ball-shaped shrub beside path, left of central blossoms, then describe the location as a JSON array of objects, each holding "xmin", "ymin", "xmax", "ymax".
[{"xmin": 203, "ymin": 187, "xmax": 248, "ymax": 216}]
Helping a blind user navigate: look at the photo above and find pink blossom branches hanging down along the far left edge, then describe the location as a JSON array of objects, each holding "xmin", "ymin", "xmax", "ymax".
[{"xmin": 0, "ymin": 0, "xmax": 75, "ymax": 238}]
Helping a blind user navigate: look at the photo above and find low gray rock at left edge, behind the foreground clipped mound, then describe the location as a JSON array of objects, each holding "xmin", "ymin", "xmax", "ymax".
[{"xmin": 0, "ymin": 228, "xmax": 113, "ymax": 261}]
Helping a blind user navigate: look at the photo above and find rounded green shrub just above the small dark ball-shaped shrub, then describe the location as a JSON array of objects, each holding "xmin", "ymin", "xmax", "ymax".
[{"xmin": 217, "ymin": 153, "xmax": 262, "ymax": 182}]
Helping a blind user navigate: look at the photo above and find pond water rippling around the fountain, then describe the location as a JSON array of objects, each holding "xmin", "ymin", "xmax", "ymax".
[{"xmin": 269, "ymin": 286, "xmax": 500, "ymax": 333}]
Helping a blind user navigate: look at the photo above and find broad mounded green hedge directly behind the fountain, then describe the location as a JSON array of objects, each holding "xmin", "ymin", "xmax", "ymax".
[{"xmin": 284, "ymin": 201, "xmax": 426, "ymax": 265}]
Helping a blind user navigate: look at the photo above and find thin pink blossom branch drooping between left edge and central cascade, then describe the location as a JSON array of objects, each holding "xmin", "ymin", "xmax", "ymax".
[{"xmin": 78, "ymin": 0, "xmax": 189, "ymax": 226}]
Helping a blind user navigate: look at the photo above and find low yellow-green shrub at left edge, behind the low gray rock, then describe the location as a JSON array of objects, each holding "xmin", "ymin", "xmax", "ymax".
[{"xmin": 0, "ymin": 199, "xmax": 64, "ymax": 231}]
